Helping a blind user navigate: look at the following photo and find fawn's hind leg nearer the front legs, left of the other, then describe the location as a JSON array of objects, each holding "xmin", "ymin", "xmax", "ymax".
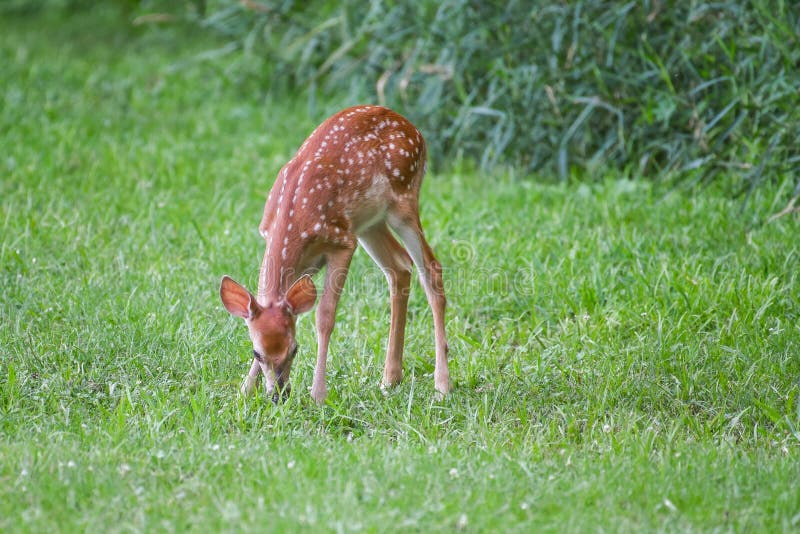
[{"xmin": 358, "ymin": 223, "xmax": 412, "ymax": 386}]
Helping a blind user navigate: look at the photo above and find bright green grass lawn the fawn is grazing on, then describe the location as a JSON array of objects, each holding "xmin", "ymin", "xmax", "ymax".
[{"xmin": 0, "ymin": 8, "xmax": 800, "ymax": 532}]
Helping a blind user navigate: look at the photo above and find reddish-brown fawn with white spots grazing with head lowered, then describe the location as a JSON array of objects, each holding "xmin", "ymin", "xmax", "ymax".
[{"xmin": 220, "ymin": 106, "xmax": 450, "ymax": 403}]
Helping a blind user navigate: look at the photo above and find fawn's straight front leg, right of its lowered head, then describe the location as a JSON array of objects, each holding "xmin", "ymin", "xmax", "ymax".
[{"xmin": 311, "ymin": 247, "xmax": 355, "ymax": 404}]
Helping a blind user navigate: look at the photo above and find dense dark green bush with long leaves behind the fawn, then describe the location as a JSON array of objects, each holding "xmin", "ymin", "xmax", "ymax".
[{"xmin": 189, "ymin": 0, "xmax": 800, "ymax": 183}]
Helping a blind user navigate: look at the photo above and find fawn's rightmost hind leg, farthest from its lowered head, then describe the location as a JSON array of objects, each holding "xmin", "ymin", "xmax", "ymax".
[{"xmin": 389, "ymin": 214, "xmax": 450, "ymax": 394}]
